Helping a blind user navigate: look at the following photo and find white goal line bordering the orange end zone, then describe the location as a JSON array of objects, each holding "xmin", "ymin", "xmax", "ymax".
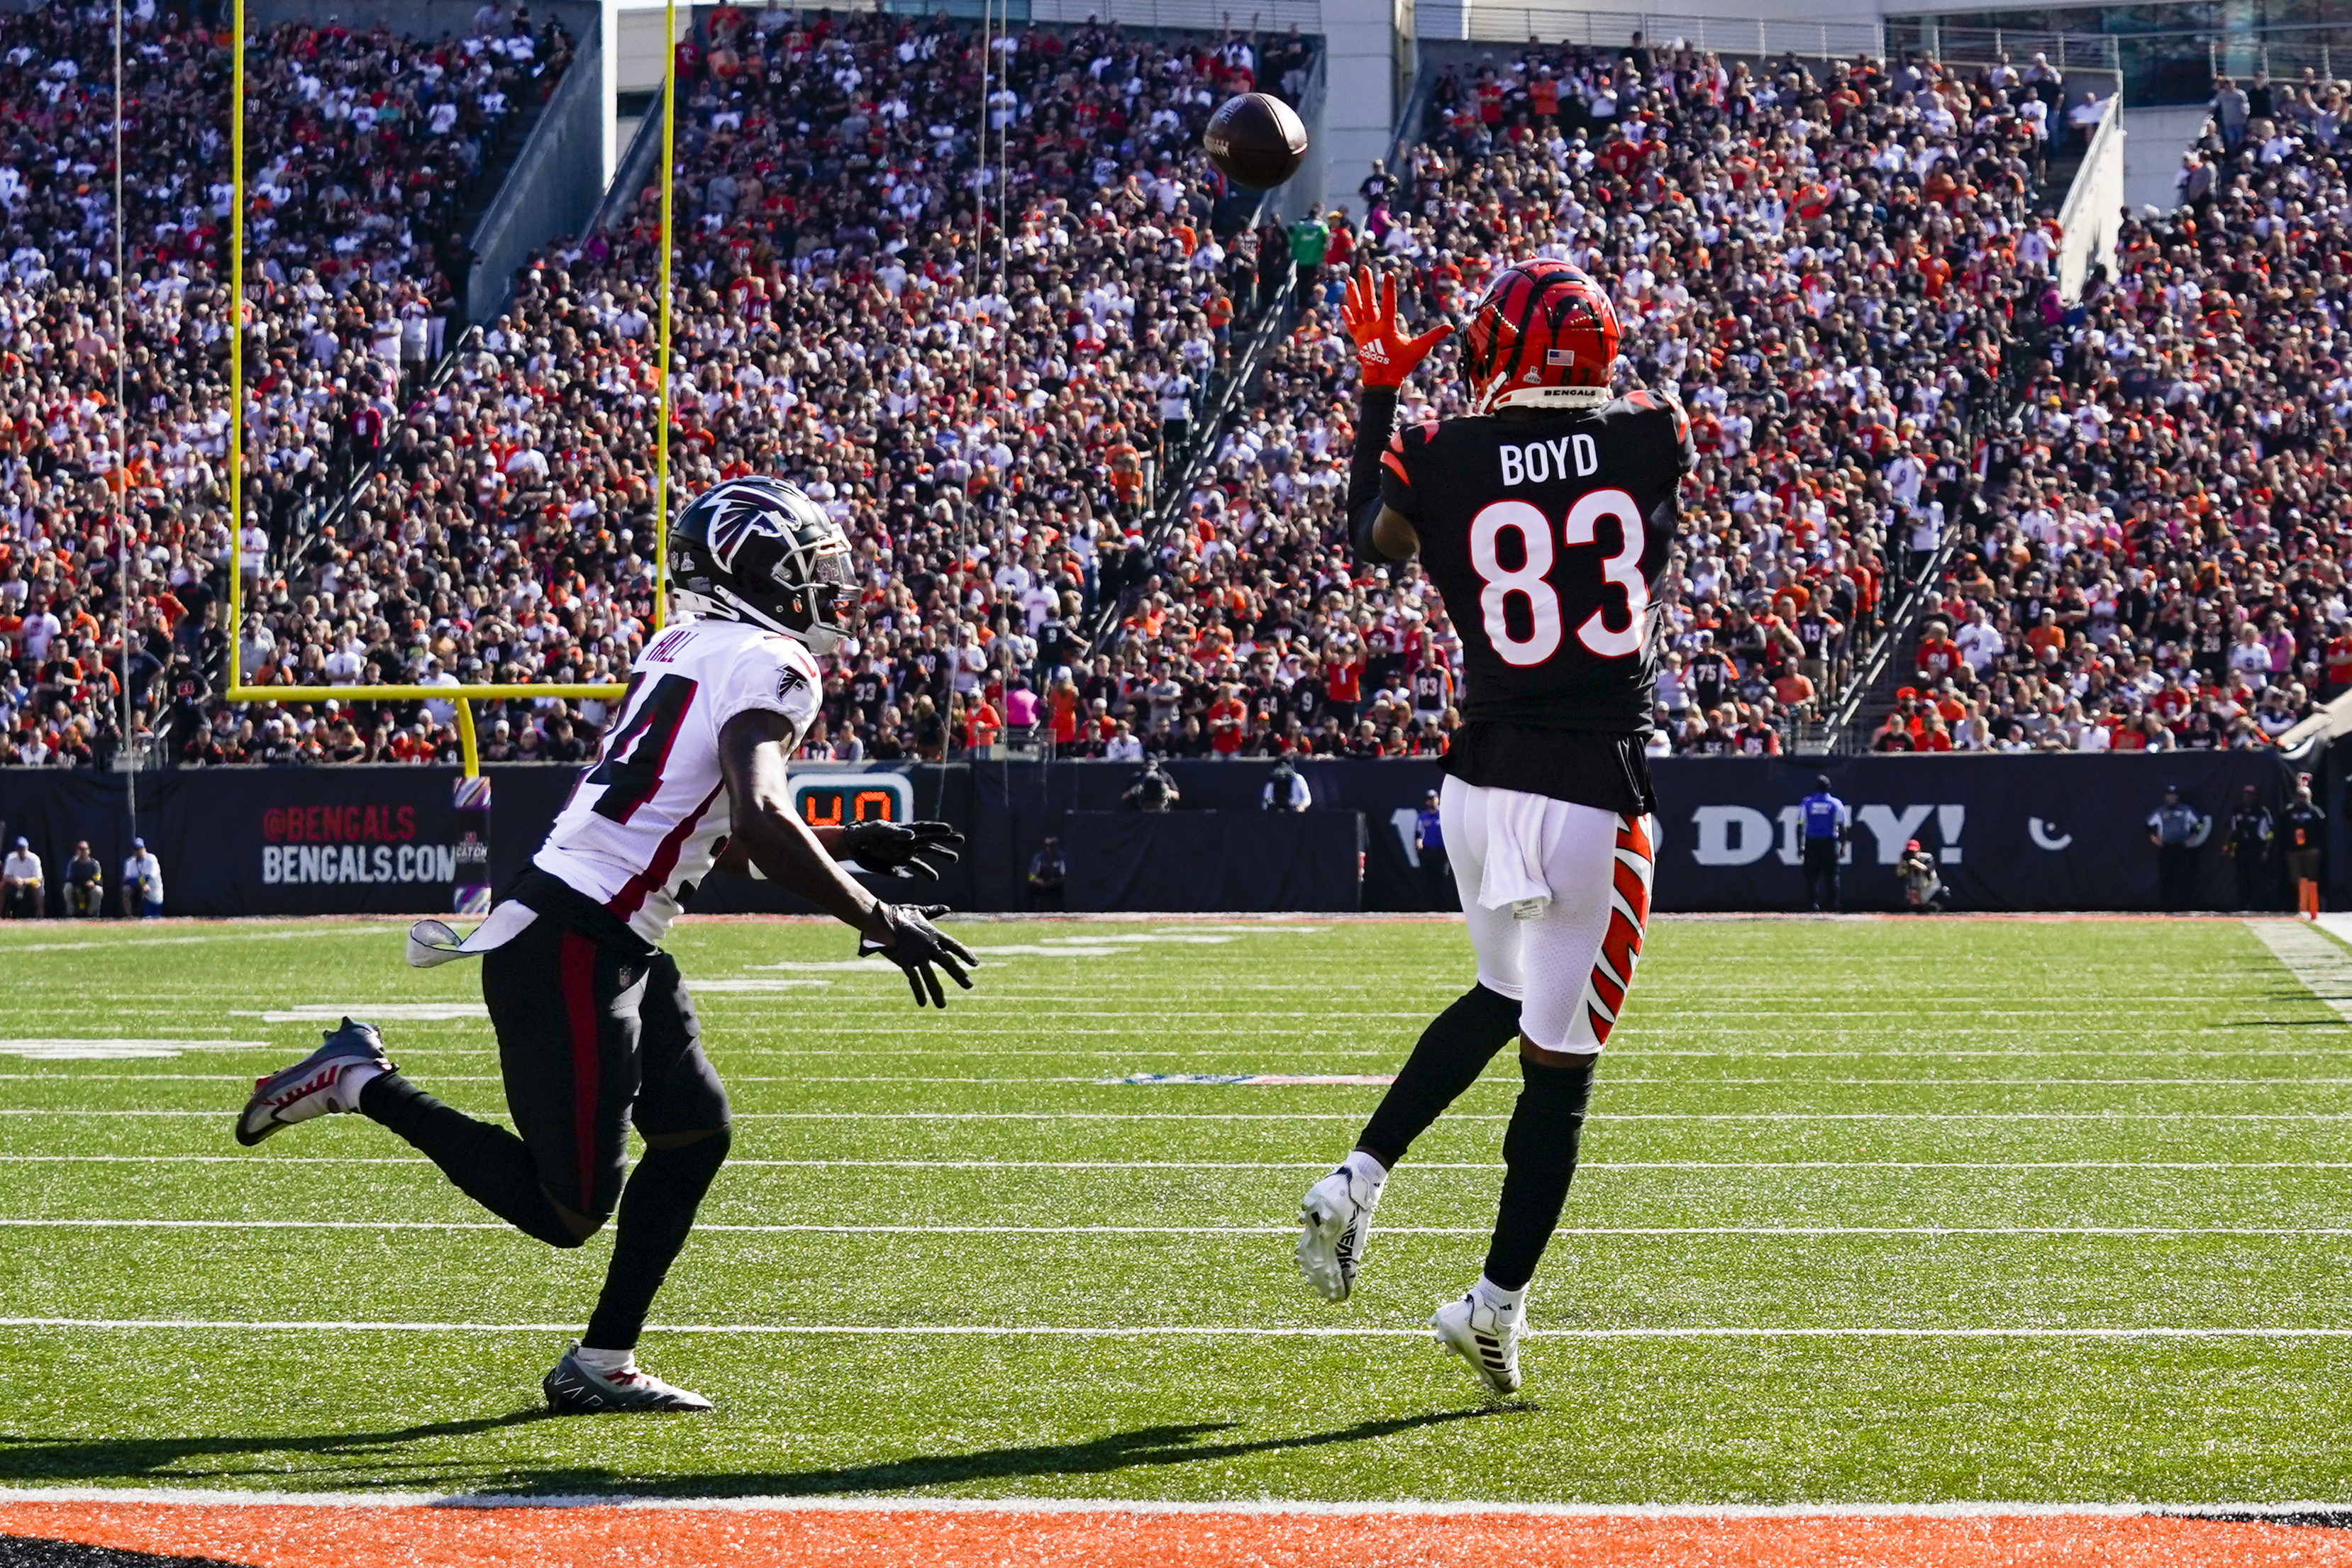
[{"xmin": 0, "ymin": 1486, "xmax": 2352, "ymax": 1521}]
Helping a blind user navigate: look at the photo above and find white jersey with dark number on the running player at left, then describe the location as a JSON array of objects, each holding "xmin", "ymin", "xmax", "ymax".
[{"xmin": 531, "ymin": 621, "xmax": 826, "ymax": 943}]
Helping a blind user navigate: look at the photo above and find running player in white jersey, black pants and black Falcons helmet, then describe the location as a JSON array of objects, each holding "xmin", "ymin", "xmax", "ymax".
[{"xmin": 238, "ymin": 477, "xmax": 974, "ymax": 1411}]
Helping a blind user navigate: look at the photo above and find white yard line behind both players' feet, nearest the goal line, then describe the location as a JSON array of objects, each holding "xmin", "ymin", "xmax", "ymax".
[{"xmin": 0, "ymin": 1316, "xmax": 2352, "ymax": 1340}]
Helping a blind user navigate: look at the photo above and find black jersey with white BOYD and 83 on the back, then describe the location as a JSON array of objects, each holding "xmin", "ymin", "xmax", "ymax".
[{"xmin": 1380, "ymin": 393, "xmax": 1696, "ymax": 733}]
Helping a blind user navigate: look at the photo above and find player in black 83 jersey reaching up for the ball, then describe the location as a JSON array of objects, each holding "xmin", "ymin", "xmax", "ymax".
[{"xmin": 1298, "ymin": 261, "xmax": 1696, "ymax": 1394}]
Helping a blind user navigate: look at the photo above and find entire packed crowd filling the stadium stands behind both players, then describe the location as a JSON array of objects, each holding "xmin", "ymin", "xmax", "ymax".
[{"xmin": 0, "ymin": 7, "xmax": 2352, "ymax": 764}]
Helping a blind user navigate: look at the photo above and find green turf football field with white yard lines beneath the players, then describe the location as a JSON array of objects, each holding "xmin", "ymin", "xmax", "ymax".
[{"xmin": 0, "ymin": 919, "xmax": 2352, "ymax": 1502}]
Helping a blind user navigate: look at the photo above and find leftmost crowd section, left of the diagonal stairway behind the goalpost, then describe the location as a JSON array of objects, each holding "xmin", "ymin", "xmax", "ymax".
[{"xmin": 0, "ymin": 5, "xmax": 572, "ymax": 764}]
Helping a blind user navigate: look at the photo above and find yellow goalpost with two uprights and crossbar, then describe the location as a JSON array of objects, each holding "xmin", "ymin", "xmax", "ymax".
[{"xmin": 221, "ymin": 0, "xmax": 692, "ymax": 778}]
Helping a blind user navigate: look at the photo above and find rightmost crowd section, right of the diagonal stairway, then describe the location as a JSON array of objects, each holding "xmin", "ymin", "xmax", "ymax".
[{"xmin": 1875, "ymin": 82, "xmax": 2352, "ymax": 750}]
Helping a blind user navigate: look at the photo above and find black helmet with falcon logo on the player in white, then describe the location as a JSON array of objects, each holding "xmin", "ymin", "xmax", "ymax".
[{"xmin": 670, "ymin": 475, "xmax": 854, "ymax": 654}]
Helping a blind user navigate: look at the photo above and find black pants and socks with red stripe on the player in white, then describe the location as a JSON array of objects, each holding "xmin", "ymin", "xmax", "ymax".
[{"xmin": 360, "ymin": 872, "xmax": 729, "ymax": 1350}]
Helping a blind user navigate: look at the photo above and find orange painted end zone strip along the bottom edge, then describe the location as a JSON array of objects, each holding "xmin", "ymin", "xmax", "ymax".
[{"xmin": 0, "ymin": 1502, "xmax": 2352, "ymax": 1568}]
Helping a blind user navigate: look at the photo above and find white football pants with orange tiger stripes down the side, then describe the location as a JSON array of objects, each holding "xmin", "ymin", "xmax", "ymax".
[{"xmin": 1437, "ymin": 774, "xmax": 1655, "ymax": 1053}]
